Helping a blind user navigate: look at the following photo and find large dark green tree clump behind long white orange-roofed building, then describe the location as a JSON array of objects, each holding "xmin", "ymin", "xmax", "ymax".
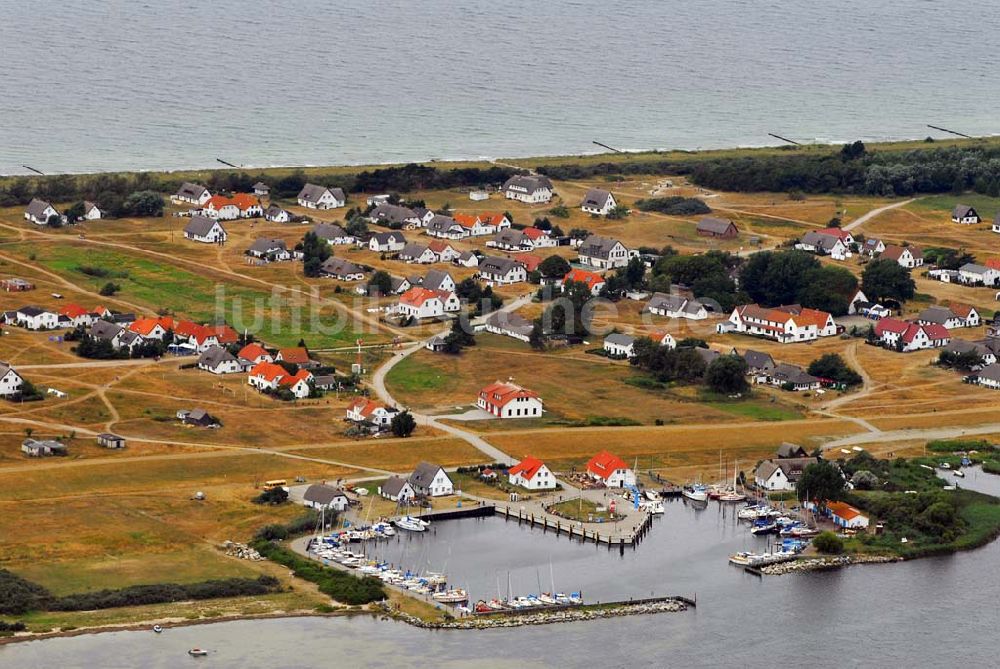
[{"xmin": 740, "ymin": 250, "xmax": 870, "ymax": 316}]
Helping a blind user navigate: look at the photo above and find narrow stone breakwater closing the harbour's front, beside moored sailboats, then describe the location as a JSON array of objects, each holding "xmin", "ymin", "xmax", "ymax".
[{"xmin": 383, "ymin": 599, "xmax": 688, "ymax": 629}]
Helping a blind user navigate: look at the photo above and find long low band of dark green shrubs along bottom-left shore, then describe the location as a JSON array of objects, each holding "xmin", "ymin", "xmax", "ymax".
[{"xmin": 0, "ymin": 569, "xmax": 281, "ymax": 615}]
